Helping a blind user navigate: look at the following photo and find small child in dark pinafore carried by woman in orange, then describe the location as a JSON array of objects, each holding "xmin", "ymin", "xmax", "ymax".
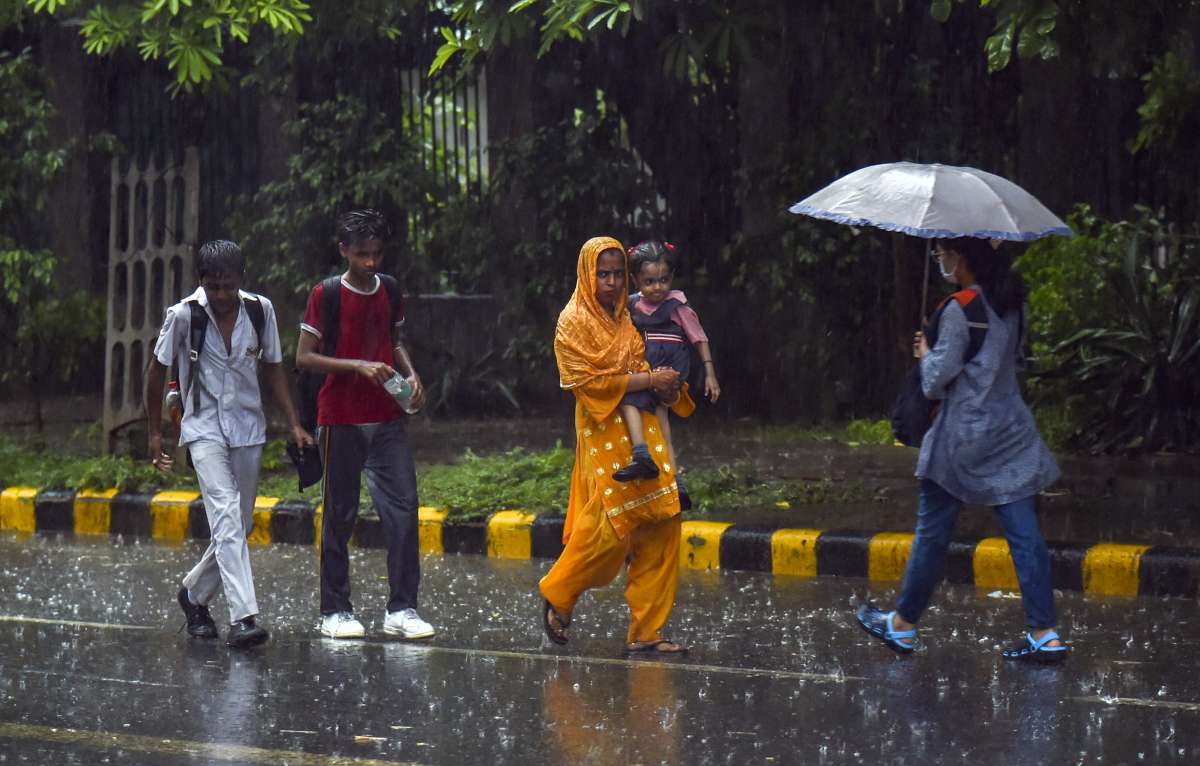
[{"xmin": 612, "ymin": 240, "xmax": 721, "ymax": 510}]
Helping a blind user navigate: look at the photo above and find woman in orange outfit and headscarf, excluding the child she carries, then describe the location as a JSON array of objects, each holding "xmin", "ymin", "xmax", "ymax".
[{"xmin": 539, "ymin": 237, "xmax": 691, "ymax": 654}]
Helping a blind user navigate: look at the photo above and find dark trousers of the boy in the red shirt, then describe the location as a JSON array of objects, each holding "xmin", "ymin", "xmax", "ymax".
[{"xmin": 320, "ymin": 420, "xmax": 421, "ymax": 615}]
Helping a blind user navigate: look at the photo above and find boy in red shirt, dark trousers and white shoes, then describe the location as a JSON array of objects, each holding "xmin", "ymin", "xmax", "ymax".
[{"xmin": 296, "ymin": 209, "xmax": 433, "ymax": 639}]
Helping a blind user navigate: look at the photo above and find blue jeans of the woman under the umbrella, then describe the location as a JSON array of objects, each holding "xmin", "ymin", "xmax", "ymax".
[{"xmin": 896, "ymin": 479, "xmax": 1058, "ymax": 629}]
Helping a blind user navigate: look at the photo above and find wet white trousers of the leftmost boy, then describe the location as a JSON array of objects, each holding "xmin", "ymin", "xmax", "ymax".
[{"xmin": 184, "ymin": 441, "xmax": 263, "ymax": 622}]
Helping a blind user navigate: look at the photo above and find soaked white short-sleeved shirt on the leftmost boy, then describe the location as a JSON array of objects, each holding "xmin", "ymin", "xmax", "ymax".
[{"xmin": 154, "ymin": 288, "xmax": 283, "ymax": 447}]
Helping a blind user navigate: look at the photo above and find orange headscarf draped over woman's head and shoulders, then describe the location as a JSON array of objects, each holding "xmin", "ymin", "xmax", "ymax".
[{"xmin": 554, "ymin": 237, "xmax": 646, "ymax": 389}]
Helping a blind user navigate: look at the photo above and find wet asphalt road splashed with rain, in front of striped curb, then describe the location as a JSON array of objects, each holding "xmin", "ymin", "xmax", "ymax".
[{"xmin": 0, "ymin": 534, "xmax": 1200, "ymax": 766}]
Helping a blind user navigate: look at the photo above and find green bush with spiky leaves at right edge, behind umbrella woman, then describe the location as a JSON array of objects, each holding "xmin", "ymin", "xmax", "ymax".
[{"xmin": 1018, "ymin": 207, "xmax": 1200, "ymax": 451}]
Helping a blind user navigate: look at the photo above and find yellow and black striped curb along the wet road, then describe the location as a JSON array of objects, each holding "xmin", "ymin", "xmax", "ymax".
[{"xmin": 0, "ymin": 486, "xmax": 1200, "ymax": 598}]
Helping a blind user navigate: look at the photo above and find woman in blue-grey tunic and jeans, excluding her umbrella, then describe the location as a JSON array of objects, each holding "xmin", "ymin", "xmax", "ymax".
[{"xmin": 858, "ymin": 237, "xmax": 1068, "ymax": 663}]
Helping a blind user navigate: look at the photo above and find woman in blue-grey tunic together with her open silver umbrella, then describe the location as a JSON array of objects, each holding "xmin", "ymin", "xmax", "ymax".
[{"xmin": 790, "ymin": 162, "xmax": 1072, "ymax": 662}]
